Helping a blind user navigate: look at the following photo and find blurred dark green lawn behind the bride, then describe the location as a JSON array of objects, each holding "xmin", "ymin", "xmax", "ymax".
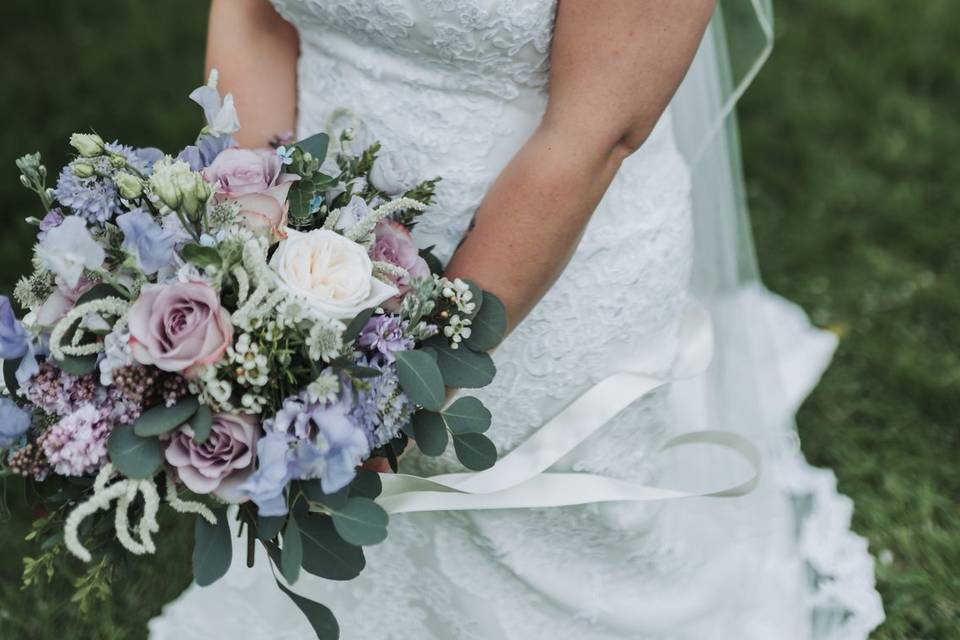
[{"xmin": 0, "ymin": 0, "xmax": 960, "ymax": 640}]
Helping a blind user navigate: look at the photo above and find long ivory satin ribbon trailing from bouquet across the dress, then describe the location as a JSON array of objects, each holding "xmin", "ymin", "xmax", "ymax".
[{"xmin": 377, "ymin": 304, "xmax": 761, "ymax": 513}]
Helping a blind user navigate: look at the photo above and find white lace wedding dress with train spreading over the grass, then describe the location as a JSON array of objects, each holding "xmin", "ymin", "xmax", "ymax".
[{"xmin": 150, "ymin": 0, "xmax": 883, "ymax": 640}]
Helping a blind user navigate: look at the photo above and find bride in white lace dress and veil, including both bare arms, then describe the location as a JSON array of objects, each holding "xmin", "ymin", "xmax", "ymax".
[{"xmin": 150, "ymin": 0, "xmax": 883, "ymax": 640}]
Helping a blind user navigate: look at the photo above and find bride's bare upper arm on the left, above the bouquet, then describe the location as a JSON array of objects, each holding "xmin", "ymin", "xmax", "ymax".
[{"xmin": 207, "ymin": 0, "xmax": 300, "ymax": 147}]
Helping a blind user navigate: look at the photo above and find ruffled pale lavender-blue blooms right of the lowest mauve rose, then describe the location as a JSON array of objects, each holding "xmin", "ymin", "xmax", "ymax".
[{"xmin": 242, "ymin": 394, "xmax": 370, "ymax": 515}]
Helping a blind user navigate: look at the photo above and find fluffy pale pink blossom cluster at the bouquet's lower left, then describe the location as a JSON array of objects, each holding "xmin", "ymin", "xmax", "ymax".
[{"xmin": 42, "ymin": 404, "xmax": 112, "ymax": 476}]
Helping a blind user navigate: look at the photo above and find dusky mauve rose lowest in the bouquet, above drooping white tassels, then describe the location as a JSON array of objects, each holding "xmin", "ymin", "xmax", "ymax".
[{"xmin": 164, "ymin": 413, "xmax": 258, "ymax": 502}]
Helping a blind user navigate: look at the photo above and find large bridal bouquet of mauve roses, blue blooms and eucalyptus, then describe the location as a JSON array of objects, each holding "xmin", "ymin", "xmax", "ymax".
[{"xmin": 0, "ymin": 74, "xmax": 506, "ymax": 638}]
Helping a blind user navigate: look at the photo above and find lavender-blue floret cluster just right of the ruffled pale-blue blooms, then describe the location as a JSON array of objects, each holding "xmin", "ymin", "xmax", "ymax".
[{"xmin": 350, "ymin": 359, "xmax": 415, "ymax": 449}]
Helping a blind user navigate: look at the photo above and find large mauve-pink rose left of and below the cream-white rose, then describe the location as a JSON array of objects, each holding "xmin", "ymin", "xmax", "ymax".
[{"xmin": 129, "ymin": 282, "xmax": 233, "ymax": 378}]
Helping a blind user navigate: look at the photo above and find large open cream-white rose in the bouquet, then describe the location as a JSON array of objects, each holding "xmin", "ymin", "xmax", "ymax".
[{"xmin": 270, "ymin": 229, "xmax": 398, "ymax": 320}]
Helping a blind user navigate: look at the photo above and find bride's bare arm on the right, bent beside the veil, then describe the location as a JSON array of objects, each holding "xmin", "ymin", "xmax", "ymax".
[{"xmin": 447, "ymin": 0, "xmax": 714, "ymax": 328}]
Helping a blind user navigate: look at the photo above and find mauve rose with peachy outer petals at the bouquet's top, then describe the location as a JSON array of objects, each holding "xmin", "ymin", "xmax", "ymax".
[{"xmin": 203, "ymin": 148, "xmax": 299, "ymax": 238}]
